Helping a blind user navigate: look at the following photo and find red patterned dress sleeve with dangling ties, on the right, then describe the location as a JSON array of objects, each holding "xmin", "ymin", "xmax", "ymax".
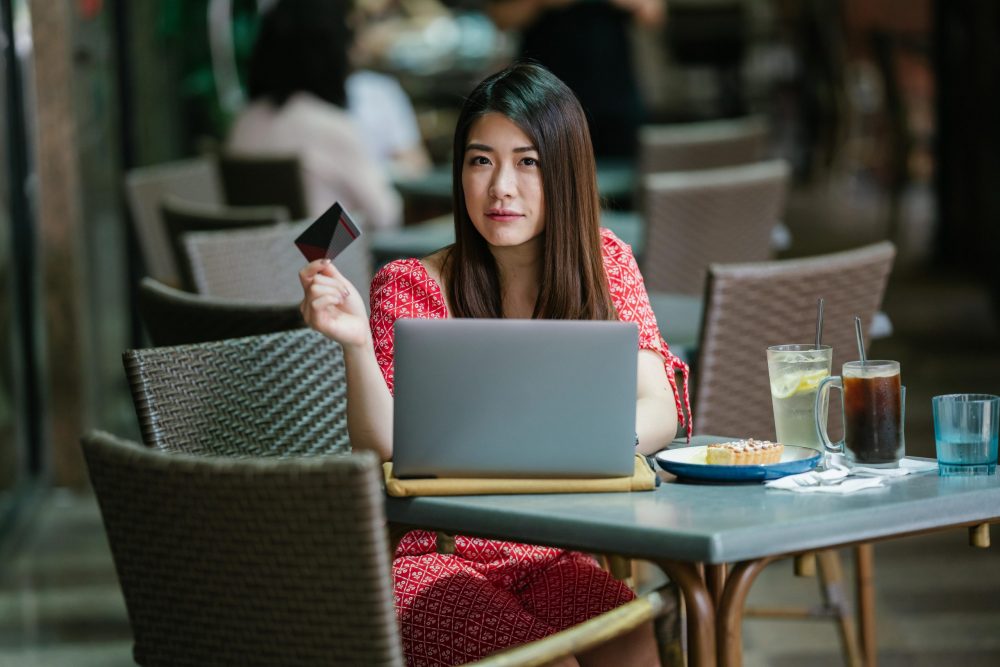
[{"xmin": 601, "ymin": 229, "xmax": 693, "ymax": 440}]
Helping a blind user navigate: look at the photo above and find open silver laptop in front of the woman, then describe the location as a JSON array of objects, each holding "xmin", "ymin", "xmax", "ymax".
[{"xmin": 393, "ymin": 319, "xmax": 638, "ymax": 478}]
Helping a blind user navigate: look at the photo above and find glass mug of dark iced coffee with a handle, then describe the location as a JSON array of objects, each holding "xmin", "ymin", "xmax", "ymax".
[{"xmin": 815, "ymin": 361, "xmax": 906, "ymax": 468}]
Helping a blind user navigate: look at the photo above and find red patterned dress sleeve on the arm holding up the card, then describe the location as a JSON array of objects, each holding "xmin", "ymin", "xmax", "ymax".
[{"xmin": 368, "ymin": 259, "xmax": 448, "ymax": 393}]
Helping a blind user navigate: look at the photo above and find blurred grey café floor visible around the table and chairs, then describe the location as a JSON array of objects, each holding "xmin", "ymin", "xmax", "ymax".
[{"xmin": 0, "ymin": 171, "xmax": 1000, "ymax": 667}]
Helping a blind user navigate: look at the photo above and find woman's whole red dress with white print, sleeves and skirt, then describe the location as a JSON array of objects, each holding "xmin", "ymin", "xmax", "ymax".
[{"xmin": 371, "ymin": 229, "xmax": 691, "ymax": 666}]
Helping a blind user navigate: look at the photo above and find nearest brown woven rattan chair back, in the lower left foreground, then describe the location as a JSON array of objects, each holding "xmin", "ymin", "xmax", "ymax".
[{"xmin": 83, "ymin": 433, "xmax": 403, "ymax": 666}]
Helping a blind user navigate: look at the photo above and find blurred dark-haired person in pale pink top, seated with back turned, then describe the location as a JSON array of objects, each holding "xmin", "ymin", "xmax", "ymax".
[{"xmin": 227, "ymin": 0, "xmax": 402, "ymax": 229}]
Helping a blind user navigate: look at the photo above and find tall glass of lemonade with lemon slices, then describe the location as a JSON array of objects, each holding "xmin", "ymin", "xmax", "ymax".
[{"xmin": 767, "ymin": 345, "xmax": 833, "ymax": 452}]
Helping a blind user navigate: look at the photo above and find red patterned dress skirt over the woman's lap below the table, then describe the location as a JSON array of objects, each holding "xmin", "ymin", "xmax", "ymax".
[{"xmin": 393, "ymin": 538, "xmax": 634, "ymax": 666}]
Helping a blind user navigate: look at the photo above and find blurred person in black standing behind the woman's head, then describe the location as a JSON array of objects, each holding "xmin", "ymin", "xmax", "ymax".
[{"xmin": 486, "ymin": 0, "xmax": 666, "ymax": 158}]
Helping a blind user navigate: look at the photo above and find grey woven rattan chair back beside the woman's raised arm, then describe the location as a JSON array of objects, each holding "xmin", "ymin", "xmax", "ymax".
[{"xmin": 123, "ymin": 329, "xmax": 350, "ymax": 456}]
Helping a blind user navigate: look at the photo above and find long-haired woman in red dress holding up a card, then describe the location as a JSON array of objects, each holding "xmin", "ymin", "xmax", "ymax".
[{"xmin": 300, "ymin": 64, "xmax": 686, "ymax": 665}]
